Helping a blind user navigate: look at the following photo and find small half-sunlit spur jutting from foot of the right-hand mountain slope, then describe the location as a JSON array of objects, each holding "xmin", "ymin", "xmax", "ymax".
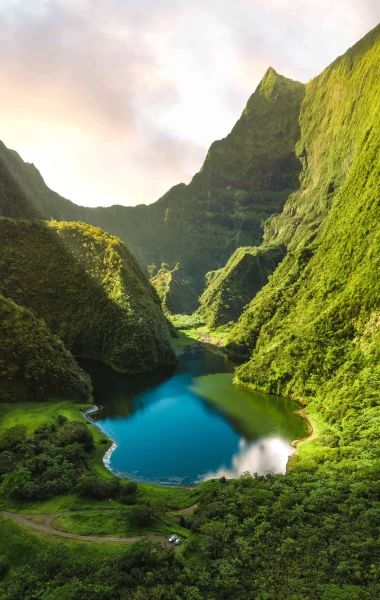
[{"xmin": 197, "ymin": 245, "xmax": 285, "ymax": 328}]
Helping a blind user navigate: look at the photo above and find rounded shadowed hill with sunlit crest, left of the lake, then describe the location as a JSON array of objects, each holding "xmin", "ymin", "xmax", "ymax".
[{"xmin": 0, "ymin": 218, "xmax": 175, "ymax": 373}]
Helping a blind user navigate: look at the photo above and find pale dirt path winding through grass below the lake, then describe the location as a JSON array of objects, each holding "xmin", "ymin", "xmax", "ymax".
[{"xmin": 0, "ymin": 510, "xmax": 171, "ymax": 546}]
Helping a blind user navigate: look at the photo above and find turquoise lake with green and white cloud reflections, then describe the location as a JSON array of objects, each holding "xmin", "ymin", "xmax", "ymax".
[{"xmin": 81, "ymin": 347, "xmax": 308, "ymax": 485}]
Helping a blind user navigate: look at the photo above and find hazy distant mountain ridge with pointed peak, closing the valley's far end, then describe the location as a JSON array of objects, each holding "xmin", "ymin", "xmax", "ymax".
[{"xmin": 0, "ymin": 68, "xmax": 305, "ymax": 293}]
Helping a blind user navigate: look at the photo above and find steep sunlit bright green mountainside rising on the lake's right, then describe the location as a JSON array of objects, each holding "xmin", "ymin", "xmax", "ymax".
[{"xmin": 230, "ymin": 27, "xmax": 380, "ymax": 432}]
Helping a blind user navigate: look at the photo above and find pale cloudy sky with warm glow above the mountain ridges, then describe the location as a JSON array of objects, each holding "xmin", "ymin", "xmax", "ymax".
[{"xmin": 0, "ymin": 0, "xmax": 380, "ymax": 206}]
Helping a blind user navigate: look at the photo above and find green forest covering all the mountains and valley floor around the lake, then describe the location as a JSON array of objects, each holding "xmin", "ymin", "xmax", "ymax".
[{"xmin": 0, "ymin": 21, "xmax": 380, "ymax": 600}]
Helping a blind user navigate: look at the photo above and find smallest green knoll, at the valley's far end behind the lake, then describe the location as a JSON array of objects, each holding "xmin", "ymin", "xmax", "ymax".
[{"xmin": 151, "ymin": 263, "xmax": 198, "ymax": 315}]
